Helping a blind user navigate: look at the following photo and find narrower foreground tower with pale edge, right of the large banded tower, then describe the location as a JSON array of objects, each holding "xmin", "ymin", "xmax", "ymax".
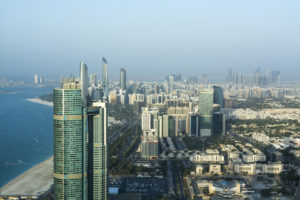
[{"xmin": 88, "ymin": 102, "xmax": 108, "ymax": 200}]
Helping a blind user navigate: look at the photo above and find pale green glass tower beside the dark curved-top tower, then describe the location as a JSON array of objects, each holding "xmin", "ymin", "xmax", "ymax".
[{"xmin": 199, "ymin": 89, "xmax": 213, "ymax": 137}]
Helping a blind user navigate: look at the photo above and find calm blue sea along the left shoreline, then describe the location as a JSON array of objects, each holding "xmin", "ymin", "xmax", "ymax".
[{"xmin": 0, "ymin": 87, "xmax": 53, "ymax": 187}]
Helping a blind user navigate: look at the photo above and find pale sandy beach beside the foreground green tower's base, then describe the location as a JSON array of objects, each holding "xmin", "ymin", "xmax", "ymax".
[{"xmin": 0, "ymin": 156, "xmax": 53, "ymax": 195}]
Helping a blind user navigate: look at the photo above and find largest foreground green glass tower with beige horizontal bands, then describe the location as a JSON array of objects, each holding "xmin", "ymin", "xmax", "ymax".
[{"xmin": 53, "ymin": 79, "xmax": 87, "ymax": 200}]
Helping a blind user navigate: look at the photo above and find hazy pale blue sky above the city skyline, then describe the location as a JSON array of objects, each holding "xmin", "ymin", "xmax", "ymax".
[{"xmin": 0, "ymin": 0, "xmax": 300, "ymax": 80}]
